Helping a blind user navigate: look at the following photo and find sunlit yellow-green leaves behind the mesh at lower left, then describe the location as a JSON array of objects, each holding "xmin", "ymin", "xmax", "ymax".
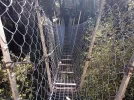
[{"xmin": 0, "ymin": 54, "xmax": 33, "ymax": 100}]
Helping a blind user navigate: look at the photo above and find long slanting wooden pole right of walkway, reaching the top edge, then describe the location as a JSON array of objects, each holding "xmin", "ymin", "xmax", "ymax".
[{"xmin": 80, "ymin": 0, "xmax": 105, "ymax": 89}]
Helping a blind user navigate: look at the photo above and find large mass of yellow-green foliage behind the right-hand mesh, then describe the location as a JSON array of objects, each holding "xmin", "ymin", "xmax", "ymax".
[{"xmin": 82, "ymin": 2, "xmax": 134, "ymax": 100}]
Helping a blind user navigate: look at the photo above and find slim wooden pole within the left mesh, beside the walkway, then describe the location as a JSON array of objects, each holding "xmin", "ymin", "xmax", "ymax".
[{"xmin": 36, "ymin": 0, "xmax": 52, "ymax": 91}]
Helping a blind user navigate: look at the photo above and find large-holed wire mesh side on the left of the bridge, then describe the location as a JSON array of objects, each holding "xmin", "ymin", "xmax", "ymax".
[{"xmin": 0, "ymin": 0, "xmax": 64, "ymax": 100}]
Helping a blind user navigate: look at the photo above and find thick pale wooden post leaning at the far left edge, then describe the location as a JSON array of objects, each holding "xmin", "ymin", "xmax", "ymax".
[{"xmin": 0, "ymin": 18, "xmax": 20, "ymax": 100}]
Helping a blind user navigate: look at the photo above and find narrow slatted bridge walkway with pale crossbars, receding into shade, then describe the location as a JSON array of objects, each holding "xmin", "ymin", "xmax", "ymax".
[{"xmin": 51, "ymin": 30, "xmax": 77, "ymax": 100}]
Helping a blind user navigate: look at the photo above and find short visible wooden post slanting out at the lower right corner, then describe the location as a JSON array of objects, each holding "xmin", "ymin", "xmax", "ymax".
[{"xmin": 115, "ymin": 53, "xmax": 134, "ymax": 100}]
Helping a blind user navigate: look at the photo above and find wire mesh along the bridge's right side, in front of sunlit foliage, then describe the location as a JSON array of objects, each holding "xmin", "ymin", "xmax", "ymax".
[{"xmin": 69, "ymin": 0, "xmax": 134, "ymax": 100}]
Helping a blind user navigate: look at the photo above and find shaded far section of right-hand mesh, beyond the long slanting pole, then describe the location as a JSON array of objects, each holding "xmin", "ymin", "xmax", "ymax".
[{"xmin": 70, "ymin": 19, "xmax": 93, "ymax": 84}]
